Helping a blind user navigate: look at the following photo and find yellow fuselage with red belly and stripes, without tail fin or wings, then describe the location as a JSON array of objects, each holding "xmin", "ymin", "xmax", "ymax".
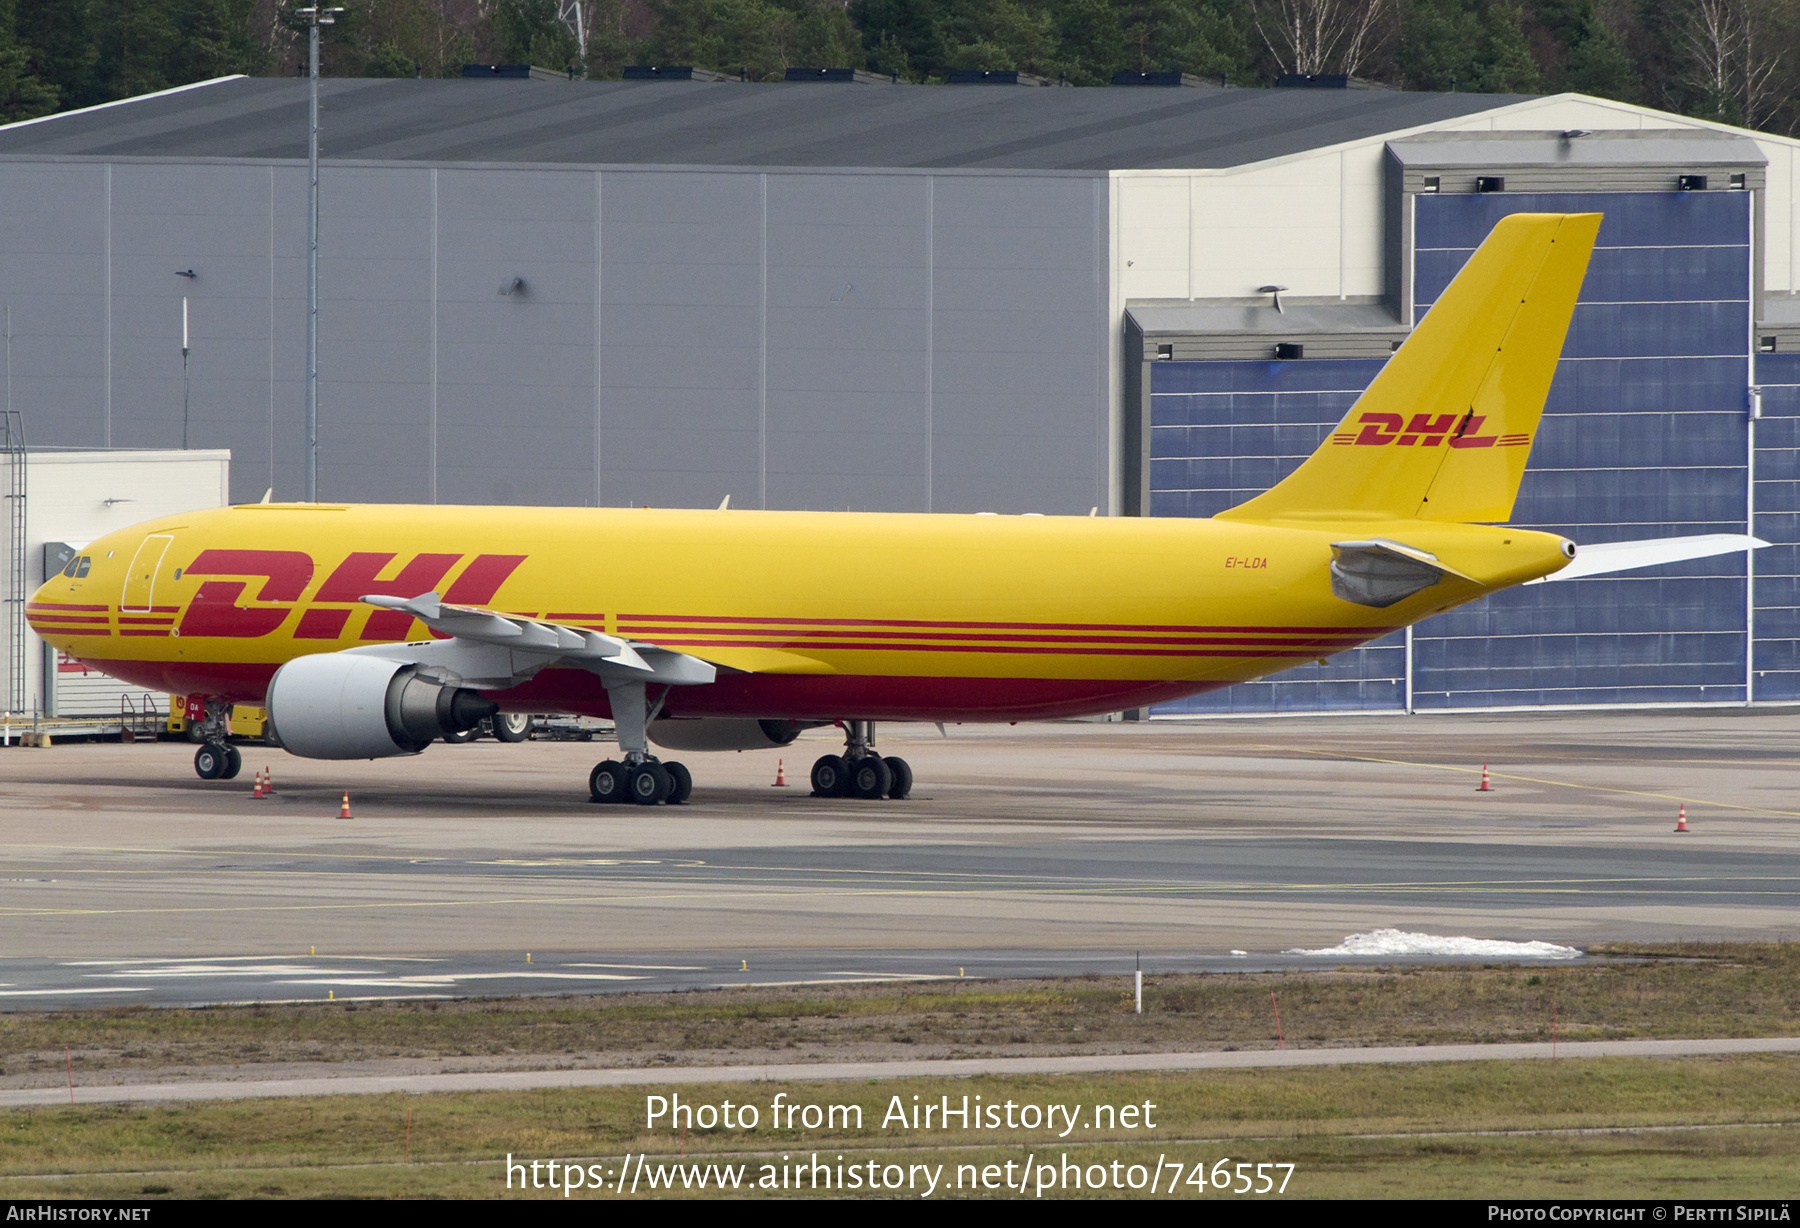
[{"xmin": 29, "ymin": 504, "xmax": 1566, "ymax": 720}]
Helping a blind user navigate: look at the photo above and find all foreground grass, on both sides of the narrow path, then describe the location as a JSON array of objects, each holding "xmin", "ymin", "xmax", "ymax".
[{"xmin": 0, "ymin": 945, "xmax": 1800, "ymax": 1199}]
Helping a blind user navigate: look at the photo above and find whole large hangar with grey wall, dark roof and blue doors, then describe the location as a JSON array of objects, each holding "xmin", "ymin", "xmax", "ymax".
[{"xmin": 0, "ymin": 77, "xmax": 1800, "ymax": 715}]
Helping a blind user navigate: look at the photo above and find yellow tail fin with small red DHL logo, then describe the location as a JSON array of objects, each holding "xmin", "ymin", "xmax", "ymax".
[{"xmin": 1219, "ymin": 212, "xmax": 1600, "ymax": 522}]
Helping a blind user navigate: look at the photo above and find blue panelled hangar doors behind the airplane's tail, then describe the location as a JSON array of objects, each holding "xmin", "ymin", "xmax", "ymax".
[{"xmin": 1148, "ymin": 191, "xmax": 1764, "ymax": 715}]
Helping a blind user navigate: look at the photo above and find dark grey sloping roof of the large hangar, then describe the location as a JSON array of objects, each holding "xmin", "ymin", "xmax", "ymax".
[{"xmin": 0, "ymin": 77, "xmax": 1523, "ymax": 171}]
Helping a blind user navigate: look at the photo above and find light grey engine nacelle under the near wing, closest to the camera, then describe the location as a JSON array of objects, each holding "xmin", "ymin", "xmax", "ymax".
[{"xmin": 266, "ymin": 652, "xmax": 500, "ymax": 760}]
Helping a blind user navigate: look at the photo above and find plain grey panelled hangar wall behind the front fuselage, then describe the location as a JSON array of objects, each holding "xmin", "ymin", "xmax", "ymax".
[{"xmin": 0, "ymin": 157, "xmax": 1109, "ymax": 513}]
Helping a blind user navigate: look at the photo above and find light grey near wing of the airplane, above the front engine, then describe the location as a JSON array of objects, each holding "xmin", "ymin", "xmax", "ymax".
[{"xmin": 349, "ymin": 592, "xmax": 718, "ymax": 690}]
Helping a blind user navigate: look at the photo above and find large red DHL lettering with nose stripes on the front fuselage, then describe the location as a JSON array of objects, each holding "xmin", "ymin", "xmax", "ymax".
[{"xmin": 27, "ymin": 549, "xmax": 527, "ymax": 641}]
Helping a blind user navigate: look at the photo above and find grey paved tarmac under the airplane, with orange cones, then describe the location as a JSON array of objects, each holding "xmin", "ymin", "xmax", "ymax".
[{"xmin": 0, "ymin": 708, "xmax": 1800, "ymax": 1010}]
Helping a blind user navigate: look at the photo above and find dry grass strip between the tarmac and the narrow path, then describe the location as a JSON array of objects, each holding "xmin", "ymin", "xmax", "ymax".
[{"xmin": 0, "ymin": 944, "xmax": 1800, "ymax": 1079}]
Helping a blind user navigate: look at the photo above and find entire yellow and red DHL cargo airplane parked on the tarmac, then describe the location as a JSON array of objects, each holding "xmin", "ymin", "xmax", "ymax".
[{"xmin": 27, "ymin": 214, "xmax": 1762, "ymax": 805}]
